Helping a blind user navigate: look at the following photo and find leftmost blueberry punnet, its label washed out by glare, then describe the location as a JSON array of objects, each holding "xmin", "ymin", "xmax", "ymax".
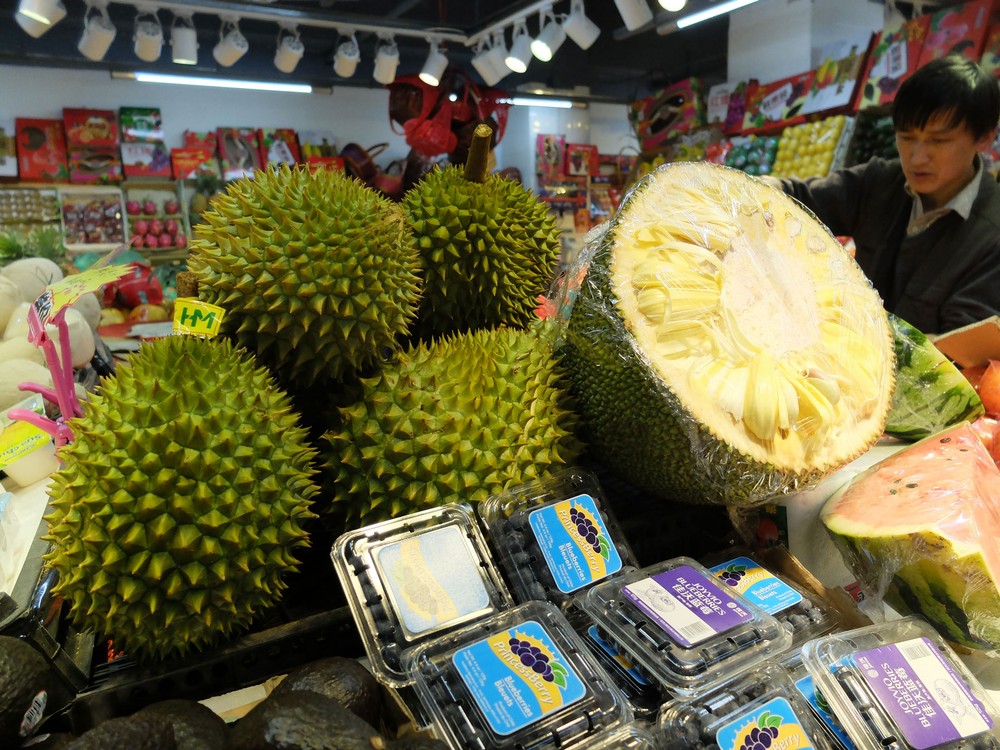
[{"xmin": 331, "ymin": 505, "xmax": 512, "ymax": 687}]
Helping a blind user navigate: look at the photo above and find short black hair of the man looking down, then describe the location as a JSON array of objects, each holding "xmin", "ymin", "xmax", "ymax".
[{"xmin": 892, "ymin": 54, "xmax": 1000, "ymax": 140}]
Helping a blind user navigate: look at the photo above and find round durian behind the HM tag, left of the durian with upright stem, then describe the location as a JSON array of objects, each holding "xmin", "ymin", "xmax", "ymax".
[{"xmin": 188, "ymin": 165, "xmax": 421, "ymax": 385}]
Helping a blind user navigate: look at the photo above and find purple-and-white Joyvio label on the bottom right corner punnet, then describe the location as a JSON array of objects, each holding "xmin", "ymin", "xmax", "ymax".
[{"xmin": 853, "ymin": 638, "xmax": 993, "ymax": 750}]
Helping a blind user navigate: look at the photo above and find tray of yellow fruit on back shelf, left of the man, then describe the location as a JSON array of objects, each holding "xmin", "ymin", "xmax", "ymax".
[{"xmin": 771, "ymin": 115, "xmax": 854, "ymax": 179}]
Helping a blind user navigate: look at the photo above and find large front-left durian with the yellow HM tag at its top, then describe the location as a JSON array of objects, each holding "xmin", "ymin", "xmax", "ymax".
[{"xmin": 45, "ymin": 336, "xmax": 317, "ymax": 658}]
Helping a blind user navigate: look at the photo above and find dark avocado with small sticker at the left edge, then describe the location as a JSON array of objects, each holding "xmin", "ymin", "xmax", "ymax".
[{"xmin": 0, "ymin": 635, "xmax": 52, "ymax": 747}]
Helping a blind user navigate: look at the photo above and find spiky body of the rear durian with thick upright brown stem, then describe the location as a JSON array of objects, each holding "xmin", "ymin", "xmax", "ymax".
[{"xmin": 402, "ymin": 166, "xmax": 560, "ymax": 340}]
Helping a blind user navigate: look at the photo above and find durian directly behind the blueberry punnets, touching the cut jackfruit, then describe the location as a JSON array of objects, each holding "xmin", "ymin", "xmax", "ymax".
[{"xmin": 326, "ymin": 328, "xmax": 582, "ymax": 524}]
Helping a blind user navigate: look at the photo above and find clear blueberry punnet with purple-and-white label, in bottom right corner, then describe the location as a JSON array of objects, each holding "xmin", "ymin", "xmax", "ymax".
[{"xmin": 802, "ymin": 617, "xmax": 1000, "ymax": 750}]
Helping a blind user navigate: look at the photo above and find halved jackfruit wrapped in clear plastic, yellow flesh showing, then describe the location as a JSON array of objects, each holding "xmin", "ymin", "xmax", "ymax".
[{"xmin": 555, "ymin": 163, "xmax": 894, "ymax": 507}]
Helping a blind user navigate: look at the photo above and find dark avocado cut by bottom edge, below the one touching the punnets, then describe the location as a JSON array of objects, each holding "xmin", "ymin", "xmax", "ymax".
[{"xmin": 229, "ymin": 690, "xmax": 387, "ymax": 750}]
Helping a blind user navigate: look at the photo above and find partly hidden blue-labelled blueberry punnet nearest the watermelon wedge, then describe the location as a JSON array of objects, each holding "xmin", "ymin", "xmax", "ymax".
[{"xmin": 702, "ymin": 548, "xmax": 838, "ymax": 648}]
